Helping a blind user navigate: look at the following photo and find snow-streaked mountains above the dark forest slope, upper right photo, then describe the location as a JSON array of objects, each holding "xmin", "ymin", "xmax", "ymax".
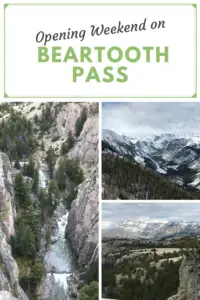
[{"xmin": 102, "ymin": 129, "xmax": 200, "ymax": 190}]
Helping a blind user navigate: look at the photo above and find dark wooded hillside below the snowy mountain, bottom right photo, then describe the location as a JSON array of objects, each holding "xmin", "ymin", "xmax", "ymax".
[{"xmin": 102, "ymin": 238, "xmax": 199, "ymax": 300}]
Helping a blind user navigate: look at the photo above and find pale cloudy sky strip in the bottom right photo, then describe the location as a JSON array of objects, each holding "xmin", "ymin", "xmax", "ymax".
[{"xmin": 102, "ymin": 202, "xmax": 200, "ymax": 229}]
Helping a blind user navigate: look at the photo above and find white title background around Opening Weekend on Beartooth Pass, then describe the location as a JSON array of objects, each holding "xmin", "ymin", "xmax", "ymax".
[{"xmin": 5, "ymin": 5, "xmax": 196, "ymax": 98}]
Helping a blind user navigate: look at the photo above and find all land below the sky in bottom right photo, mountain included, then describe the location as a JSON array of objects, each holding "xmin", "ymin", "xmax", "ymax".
[{"xmin": 102, "ymin": 220, "xmax": 200, "ymax": 300}]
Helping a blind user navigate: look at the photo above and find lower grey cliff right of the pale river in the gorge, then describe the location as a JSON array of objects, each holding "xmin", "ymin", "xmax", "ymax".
[{"xmin": 66, "ymin": 170, "xmax": 99, "ymax": 278}]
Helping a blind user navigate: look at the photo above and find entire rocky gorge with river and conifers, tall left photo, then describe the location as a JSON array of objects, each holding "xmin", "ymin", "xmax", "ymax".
[{"xmin": 0, "ymin": 103, "xmax": 98, "ymax": 300}]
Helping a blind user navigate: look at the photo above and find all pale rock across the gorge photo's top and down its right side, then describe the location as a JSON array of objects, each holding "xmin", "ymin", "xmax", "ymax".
[{"xmin": 2, "ymin": 102, "xmax": 99, "ymax": 296}]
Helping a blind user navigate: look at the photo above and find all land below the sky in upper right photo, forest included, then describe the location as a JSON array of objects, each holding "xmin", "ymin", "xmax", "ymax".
[{"xmin": 102, "ymin": 130, "xmax": 200, "ymax": 199}]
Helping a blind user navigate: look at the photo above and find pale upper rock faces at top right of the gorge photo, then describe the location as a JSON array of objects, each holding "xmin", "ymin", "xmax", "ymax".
[{"xmin": 55, "ymin": 103, "xmax": 99, "ymax": 169}]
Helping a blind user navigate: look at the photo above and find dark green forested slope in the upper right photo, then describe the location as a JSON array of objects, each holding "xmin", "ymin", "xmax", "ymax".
[{"xmin": 102, "ymin": 153, "xmax": 193, "ymax": 200}]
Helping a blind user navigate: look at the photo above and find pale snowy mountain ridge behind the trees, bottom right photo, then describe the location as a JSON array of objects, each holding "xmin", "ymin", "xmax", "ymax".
[{"xmin": 103, "ymin": 218, "xmax": 200, "ymax": 239}]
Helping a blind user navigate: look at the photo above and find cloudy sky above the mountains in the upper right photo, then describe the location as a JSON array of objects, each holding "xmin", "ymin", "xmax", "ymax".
[{"xmin": 102, "ymin": 102, "xmax": 200, "ymax": 137}]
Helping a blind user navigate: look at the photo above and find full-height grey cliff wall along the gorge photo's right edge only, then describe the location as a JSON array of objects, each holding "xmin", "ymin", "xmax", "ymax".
[{"xmin": 66, "ymin": 103, "xmax": 99, "ymax": 280}]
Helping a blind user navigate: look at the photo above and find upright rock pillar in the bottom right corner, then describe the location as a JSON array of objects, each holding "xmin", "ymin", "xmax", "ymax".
[{"xmin": 168, "ymin": 258, "xmax": 200, "ymax": 300}]
